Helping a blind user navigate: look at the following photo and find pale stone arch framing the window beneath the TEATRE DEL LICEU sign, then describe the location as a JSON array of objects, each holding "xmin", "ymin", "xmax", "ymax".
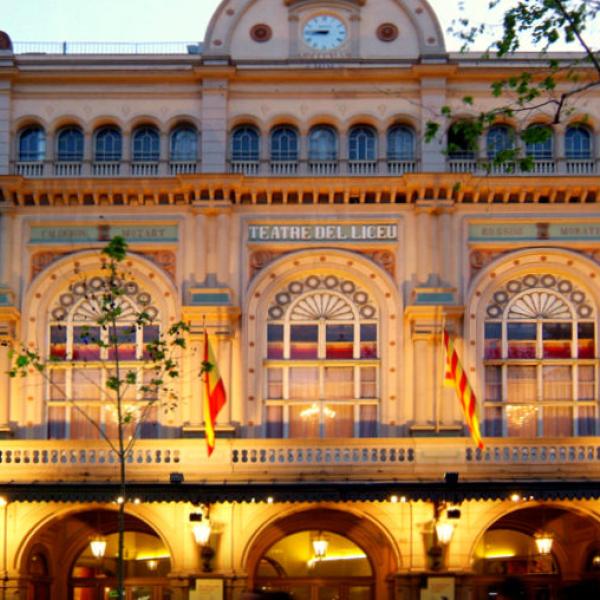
[{"xmin": 242, "ymin": 248, "xmax": 404, "ymax": 432}]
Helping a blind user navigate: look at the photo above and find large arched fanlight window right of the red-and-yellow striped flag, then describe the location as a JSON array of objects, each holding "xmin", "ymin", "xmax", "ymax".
[{"xmin": 484, "ymin": 273, "xmax": 597, "ymax": 438}]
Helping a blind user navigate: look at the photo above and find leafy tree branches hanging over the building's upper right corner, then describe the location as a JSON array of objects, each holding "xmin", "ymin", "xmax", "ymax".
[{"xmin": 425, "ymin": 0, "xmax": 600, "ymax": 170}]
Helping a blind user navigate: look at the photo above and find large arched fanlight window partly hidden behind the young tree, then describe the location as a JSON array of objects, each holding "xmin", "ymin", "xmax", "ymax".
[{"xmin": 46, "ymin": 277, "xmax": 159, "ymax": 439}]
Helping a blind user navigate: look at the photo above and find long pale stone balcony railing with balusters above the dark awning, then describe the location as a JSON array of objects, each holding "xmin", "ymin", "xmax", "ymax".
[{"xmin": 0, "ymin": 438, "xmax": 600, "ymax": 483}]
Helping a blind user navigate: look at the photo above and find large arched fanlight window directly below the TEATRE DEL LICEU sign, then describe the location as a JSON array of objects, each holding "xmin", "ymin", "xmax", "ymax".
[{"xmin": 265, "ymin": 274, "xmax": 379, "ymax": 438}]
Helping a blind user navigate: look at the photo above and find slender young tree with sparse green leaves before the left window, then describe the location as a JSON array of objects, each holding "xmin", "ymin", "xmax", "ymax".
[{"xmin": 9, "ymin": 237, "xmax": 190, "ymax": 599}]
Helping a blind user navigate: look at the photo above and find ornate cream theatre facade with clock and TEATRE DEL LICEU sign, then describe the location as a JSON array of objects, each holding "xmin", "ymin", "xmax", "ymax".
[{"xmin": 0, "ymin": 0, "xmax": 600, "ymax": 600}]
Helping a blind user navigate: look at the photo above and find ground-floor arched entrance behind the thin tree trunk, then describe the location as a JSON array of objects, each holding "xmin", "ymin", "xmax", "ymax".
[{"xmin": 19, "ymin": 509, "xmax": 171, "ymax": 600}]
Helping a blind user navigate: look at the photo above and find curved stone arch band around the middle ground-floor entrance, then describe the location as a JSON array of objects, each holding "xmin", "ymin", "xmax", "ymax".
[{"xmin": 243, "ymin": 507, "xmax": 401, "ymax": 600}]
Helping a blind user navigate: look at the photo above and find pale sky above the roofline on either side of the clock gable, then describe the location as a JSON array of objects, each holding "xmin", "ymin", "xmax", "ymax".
[{"xmin": 0, "ymin": 0, "xmax": 600, "ymax": 50}]
